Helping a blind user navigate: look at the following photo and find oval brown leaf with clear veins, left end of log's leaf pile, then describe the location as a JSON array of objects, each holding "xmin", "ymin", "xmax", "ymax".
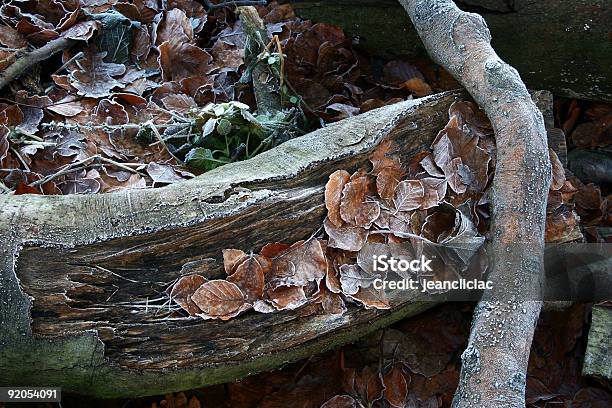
[{"xmin": 191, "ymin": 280, "xmax": 251, "ymax": 320}]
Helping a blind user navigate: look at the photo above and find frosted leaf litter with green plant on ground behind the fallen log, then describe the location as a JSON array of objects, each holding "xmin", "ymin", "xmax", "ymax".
[{"xmin": 0, "ymin": 0, "xmax": 440, "ymax": 194}]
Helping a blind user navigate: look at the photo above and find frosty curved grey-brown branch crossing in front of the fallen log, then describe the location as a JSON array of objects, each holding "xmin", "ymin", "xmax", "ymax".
[{"xmin": 400, "ymin": 0, "xmax": 551, "ymax": 408}]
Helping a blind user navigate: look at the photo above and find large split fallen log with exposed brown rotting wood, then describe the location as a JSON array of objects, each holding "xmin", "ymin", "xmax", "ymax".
[{"xmin": 0, "ymin": 92, "xmax": 549, "ymax": 397}]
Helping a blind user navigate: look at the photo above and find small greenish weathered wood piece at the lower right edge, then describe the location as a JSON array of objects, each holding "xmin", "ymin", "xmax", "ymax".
[{"xmin": 582, "ymin": 306, "xmax": 612, "ymax": 382}]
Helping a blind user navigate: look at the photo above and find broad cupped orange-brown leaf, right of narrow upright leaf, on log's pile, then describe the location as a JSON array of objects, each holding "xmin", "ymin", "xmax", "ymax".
[{"xmin": 340, "ymin": 176, "xmax": 380, "ymax": 228}]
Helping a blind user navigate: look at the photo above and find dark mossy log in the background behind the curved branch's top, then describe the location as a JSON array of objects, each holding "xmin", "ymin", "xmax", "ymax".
[{"xmin": 289, "ymin": 0, "xmax": 612, "ymax": 102}]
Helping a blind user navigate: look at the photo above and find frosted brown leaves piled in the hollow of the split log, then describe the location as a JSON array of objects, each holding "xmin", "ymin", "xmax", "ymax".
[{"xmin": 169, "ymin": 101, "xmax": 581, "ymax": 320}]
